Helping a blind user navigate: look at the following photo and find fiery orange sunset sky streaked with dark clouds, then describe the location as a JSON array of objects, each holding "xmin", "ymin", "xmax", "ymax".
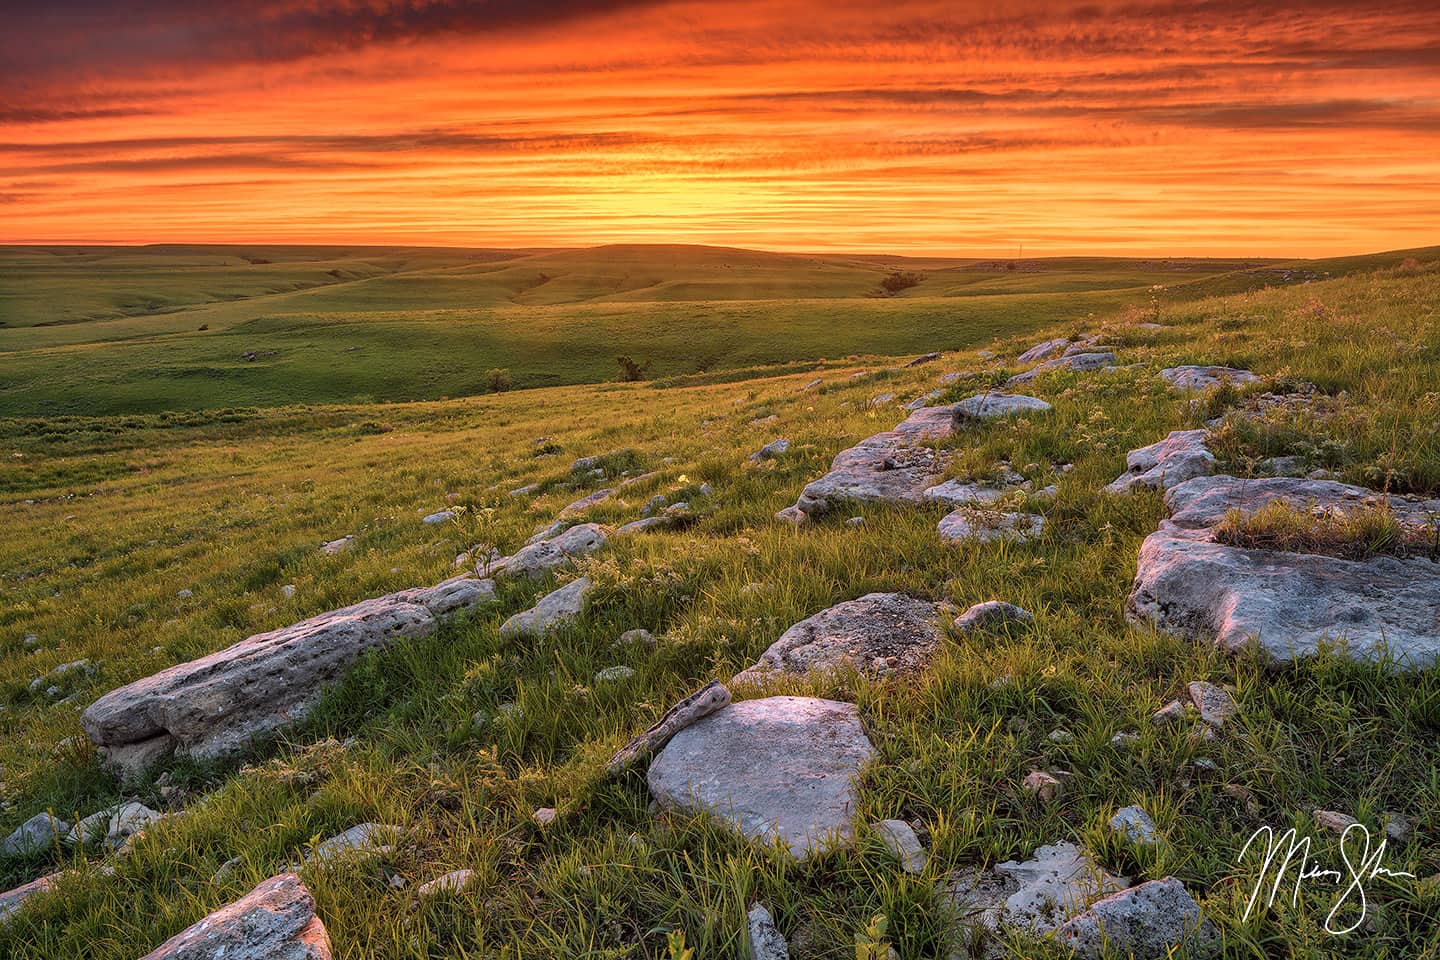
[{"xmin": 0, "ymin": 0, "xmax": 1440, "ymax": 256}]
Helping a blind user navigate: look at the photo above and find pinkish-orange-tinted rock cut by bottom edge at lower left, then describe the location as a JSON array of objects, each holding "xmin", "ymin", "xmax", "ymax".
[{"xmin": 141, "ymin": 874, "xmax": 330, "ymax": 960}]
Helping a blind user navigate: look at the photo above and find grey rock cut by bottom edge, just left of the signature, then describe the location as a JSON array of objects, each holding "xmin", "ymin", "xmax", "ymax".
[{"xmin": 1056, "ymin": 877, "xmax": 1220, "ymax": 959}]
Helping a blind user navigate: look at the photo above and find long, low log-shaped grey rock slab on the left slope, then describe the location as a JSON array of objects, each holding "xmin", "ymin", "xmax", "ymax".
[{"xmin": 81, "ymin": 577, "xmax": 494, "ymax": 774}]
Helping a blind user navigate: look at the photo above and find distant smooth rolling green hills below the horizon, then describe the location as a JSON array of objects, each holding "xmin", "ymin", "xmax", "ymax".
[{"xmin": 11, "ymin": 246, "xmax": 1440, "ymax": 416}]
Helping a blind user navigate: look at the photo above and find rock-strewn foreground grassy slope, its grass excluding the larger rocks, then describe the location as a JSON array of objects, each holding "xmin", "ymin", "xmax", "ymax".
[{"xmin": 0, "ymin": 259, "xmax": 1440, "ymax": 960}]
